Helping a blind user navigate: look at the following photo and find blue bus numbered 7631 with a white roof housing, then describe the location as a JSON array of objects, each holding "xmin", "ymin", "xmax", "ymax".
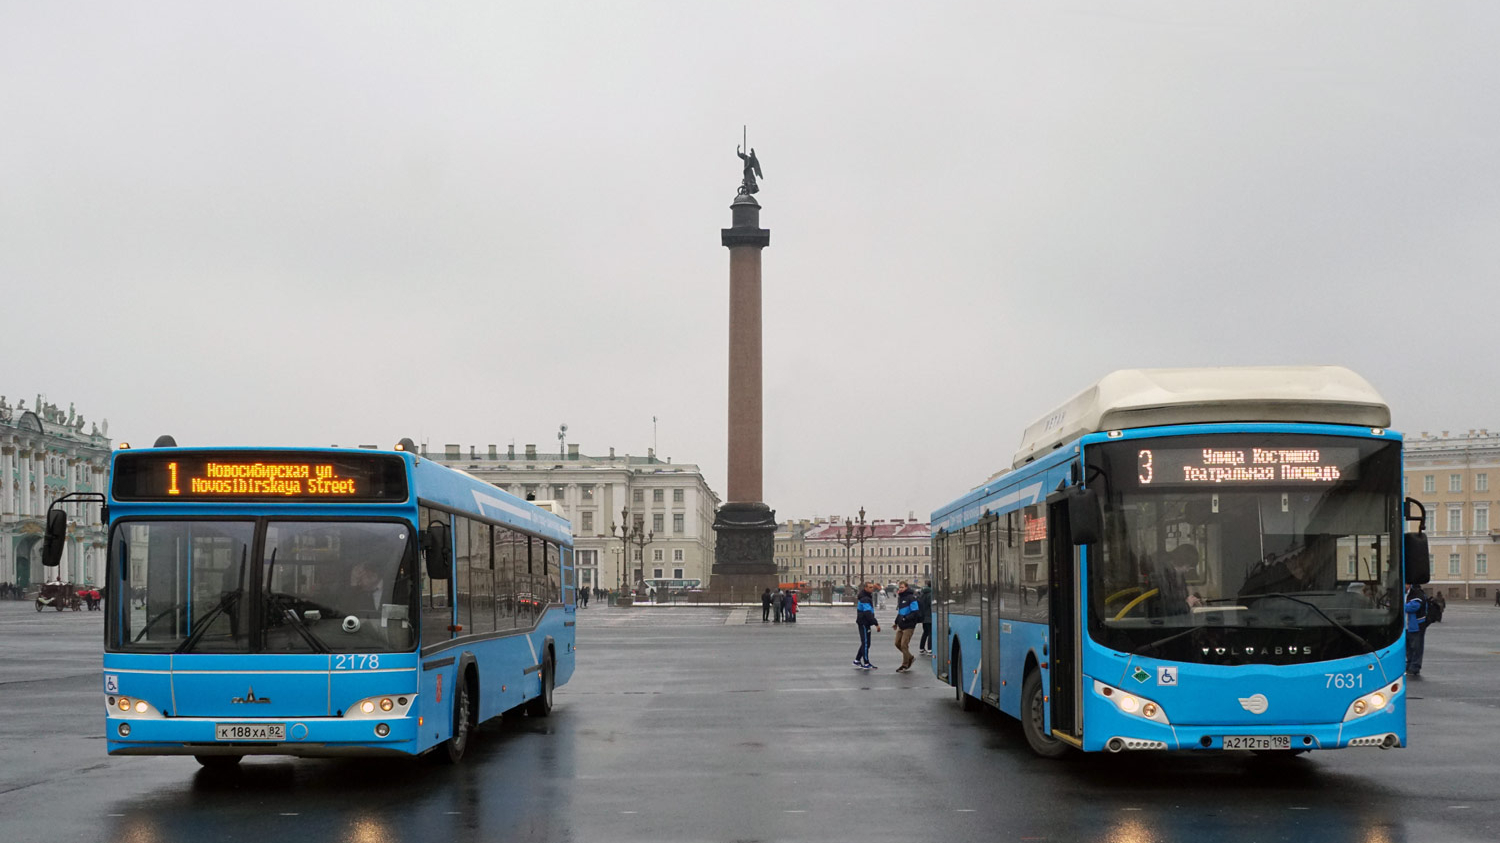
[{"xmin": 933, "ymin": 366, "xmax": 1430, "ymax": 758}]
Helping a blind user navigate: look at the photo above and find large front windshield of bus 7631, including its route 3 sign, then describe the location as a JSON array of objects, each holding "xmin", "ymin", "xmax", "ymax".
[{"xmin": 1088, "ymin": 434, "xmax": 1403, "ymax": 665}]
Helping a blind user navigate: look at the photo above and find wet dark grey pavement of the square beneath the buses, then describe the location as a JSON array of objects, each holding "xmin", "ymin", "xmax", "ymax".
[{"xmin": 0, "ymin": 602, "xmax": 1500, "ymax": 843}]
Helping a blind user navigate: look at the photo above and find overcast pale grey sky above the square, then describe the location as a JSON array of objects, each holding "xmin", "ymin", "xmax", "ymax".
[{"xmin": 0, "ymin": 0, "xmax": 1500, "ymax": 518}]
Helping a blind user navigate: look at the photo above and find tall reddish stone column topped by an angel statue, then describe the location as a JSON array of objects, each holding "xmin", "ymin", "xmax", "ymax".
[{"xmin": 710, "ymin": 141, "xmax": 777, "ymax": 600}]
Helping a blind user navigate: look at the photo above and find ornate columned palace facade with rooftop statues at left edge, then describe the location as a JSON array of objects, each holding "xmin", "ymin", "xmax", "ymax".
[{"xmin": 0, "ymin": 396, "xmax": 110, "ymax": 587}]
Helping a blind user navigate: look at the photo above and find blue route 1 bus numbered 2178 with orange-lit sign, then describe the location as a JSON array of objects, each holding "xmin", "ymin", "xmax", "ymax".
[{"xmin": 45, "ymin": 437, "xmax": 576, "ymax": 767}]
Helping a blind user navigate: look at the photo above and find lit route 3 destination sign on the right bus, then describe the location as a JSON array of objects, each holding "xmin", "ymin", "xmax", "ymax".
[{"xmin": 1136, "ymin": 446, "xmax": 1359, "ymax": 486}]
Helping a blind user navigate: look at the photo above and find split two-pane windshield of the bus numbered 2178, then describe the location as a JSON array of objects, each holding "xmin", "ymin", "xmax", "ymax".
[{"xmin": 108, "ymin": 519, "xmax": 417, "ymax": 653}]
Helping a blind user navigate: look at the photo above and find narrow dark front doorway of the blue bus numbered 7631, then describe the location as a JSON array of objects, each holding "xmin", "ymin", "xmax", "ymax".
[{"xmin": 1047, "ymin": 494, "xmax": 1083, "ymax": 743}]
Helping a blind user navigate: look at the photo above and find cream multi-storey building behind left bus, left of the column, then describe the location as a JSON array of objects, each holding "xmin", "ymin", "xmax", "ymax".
[{"xmin": 422, "ymin": 446, "xmax": 719, "ymax": 588}]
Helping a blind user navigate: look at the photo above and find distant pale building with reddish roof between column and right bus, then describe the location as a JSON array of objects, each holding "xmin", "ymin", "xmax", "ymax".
[{"xmin": 803, "ymin": 516, "xmax": 933, "ymax": 585}]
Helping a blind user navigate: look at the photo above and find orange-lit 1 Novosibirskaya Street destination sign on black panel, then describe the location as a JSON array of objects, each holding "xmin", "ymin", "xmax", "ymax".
[{"xmin": 113, "ymin": 452, "xmax": 407, "ymax": 503}]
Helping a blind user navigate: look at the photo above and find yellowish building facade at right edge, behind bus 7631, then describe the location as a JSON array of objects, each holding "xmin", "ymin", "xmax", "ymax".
[{"xmin": 1406, "ymin": 431, "xmax": 1500, "ymax": 600}]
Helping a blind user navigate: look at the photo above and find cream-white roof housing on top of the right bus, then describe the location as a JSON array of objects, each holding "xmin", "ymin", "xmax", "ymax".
[{"xmin": 1013, "ymin": 366, "xmax": 1391, "ymax": 468}]
